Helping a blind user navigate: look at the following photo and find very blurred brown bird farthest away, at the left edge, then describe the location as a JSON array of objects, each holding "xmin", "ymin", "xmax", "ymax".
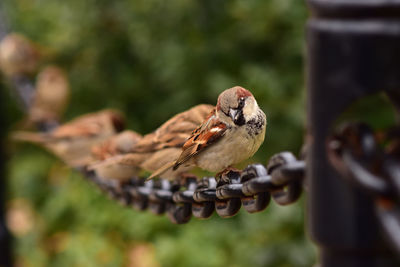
[{"xmin": 0, "ymin": 33, "xmax": 40, "ymax": 77}]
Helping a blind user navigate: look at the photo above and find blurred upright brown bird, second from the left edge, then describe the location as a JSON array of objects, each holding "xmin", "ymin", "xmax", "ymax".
[{"xmin": 29, "ymin": 66, "xmax": 70, "ymax": 126}]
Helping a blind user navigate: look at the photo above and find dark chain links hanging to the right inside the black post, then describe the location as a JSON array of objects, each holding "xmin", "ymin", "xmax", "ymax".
[{"xmin": 328, "ymin": 124, "xmax": 400, "ymax": 253}]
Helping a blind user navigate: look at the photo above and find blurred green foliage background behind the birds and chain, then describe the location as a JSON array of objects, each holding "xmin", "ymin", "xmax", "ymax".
[{"xmin": 0, "ymin": 0, "xmax": 316, "ymax": 267}]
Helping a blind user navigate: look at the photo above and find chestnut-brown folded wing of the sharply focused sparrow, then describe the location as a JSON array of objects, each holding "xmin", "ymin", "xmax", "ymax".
[{"xmin": 173, "ymin": 115, "xmax": 227, "ymax": 170}]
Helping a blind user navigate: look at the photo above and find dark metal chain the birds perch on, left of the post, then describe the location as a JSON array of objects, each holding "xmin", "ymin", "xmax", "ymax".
[{"xmin": 81, "ymin": 152, "xmax": 305, "ymax": 224}]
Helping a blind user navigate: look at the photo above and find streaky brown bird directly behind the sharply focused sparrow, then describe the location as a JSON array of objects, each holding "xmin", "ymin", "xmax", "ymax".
[{"xmin": 88, "ymin": 104, "xmax": 214, "ymax": 180}]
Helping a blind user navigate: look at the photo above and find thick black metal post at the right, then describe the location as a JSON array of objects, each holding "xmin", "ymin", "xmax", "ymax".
[{"xmin": 307, "ymin": 0, "xmax": 400, "ymax": 267}]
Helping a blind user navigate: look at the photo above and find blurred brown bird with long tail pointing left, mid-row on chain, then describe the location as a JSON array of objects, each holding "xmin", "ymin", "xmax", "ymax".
[{"xmin": 11, "ymin": 109, "xmax": 124, "ymax": 167}]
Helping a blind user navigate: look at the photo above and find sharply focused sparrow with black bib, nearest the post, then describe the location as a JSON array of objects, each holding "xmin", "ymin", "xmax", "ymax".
[{"xmin": 148, "ymin": 86, "xmax": 267, "ymax": 179}]
